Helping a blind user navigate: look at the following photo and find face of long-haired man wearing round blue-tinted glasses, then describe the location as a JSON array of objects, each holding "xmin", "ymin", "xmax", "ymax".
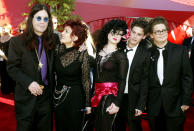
[{"xmin": 32, "ymin": 10, "xmax": 49, "ymax": 36}]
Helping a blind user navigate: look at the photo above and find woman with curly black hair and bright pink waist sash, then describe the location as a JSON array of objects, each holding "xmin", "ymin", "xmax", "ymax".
[{"xmin": 91, "ymin": 20, "xmax": 128, "ymax": 131}]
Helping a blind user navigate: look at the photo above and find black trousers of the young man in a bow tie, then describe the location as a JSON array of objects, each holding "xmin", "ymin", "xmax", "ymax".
[{"xmin": 114, "ymin": 94, "xmax": 142, "ymax": 131}]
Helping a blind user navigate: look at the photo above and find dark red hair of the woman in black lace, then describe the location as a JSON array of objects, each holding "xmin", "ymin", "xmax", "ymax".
[{"xmin": 63, "ymin": 19, "xmax": 88, "ymax": 48}]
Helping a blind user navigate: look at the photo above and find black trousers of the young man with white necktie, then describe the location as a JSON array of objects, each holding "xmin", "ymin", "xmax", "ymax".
[{"xmin": 149, "ymin": 106, "xmax": 185, "ymax": 131}]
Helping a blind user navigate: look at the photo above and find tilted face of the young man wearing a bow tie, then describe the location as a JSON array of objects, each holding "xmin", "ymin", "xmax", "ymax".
[{"xmin": 129, "ymin": 26, "xmax": 145, "ymax": 46}]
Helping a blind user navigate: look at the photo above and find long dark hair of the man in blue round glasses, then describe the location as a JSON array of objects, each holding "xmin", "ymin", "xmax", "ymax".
[{"xmin": 22, "ymin": 3, "xmax": 55, "ymax": 49}]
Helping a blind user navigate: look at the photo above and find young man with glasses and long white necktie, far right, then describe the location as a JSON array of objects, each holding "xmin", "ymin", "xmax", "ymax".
[{"xmin": 147, "ymin": 17, "xmax": 192, "ymax": 131}]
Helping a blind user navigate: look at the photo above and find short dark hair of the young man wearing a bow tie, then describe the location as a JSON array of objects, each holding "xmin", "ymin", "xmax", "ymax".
[{"xmin": 131, "ymin": 17, "xmax": 149, "ymax": 35}]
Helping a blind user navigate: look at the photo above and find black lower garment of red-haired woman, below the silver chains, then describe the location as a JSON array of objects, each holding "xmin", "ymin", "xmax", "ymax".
[{"xmin": 55, "ymin": 86, "xmax": 85, "ymax": 131}]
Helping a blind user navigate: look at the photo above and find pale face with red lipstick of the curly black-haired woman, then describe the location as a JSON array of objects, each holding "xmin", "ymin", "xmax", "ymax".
[{"xmin": 108, "ymin": 30, "xmax": 123, "ymax": 44}]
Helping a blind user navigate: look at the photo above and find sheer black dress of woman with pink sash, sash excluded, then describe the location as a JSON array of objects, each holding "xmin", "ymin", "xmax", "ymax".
[{"xmin": 94, "ymin": 50, "xmax": 128, "ymax": 131}]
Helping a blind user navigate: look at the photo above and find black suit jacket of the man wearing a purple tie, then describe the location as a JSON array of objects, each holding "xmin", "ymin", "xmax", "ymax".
[{"xmin": 7, "ymin": 36, "xmax": 59, "ymax": 118}]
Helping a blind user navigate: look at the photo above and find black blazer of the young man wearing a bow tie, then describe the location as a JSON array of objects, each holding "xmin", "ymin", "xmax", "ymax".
[{"xmin": 127, "ymin": 43, "xmax": 150, "ymax": 116}]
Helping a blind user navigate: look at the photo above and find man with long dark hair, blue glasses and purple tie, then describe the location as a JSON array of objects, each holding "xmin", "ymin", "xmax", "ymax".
[{"xmin": 7, "ymin": 4, "xmax": 60, "ymax": 131}]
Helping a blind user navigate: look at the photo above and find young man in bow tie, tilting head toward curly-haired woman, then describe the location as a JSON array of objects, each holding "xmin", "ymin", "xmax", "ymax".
[{"xmin": 115, "ymin": 18, "xmax": 149, "ymax": 131}]
